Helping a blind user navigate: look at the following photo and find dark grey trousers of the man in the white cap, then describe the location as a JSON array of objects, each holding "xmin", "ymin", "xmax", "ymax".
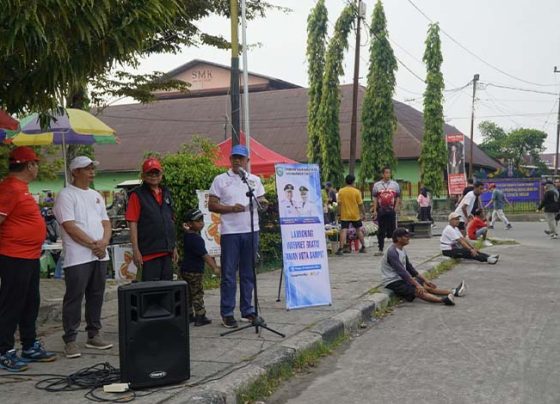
[{"xmin": 62, "ymin": 261, "xmax": 108, "ymax": 343}]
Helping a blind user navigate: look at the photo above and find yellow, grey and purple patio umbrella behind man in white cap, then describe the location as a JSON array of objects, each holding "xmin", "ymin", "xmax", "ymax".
[{"xmin": 4, "ymin": 108, "xmax": 117, "ymax": 182}]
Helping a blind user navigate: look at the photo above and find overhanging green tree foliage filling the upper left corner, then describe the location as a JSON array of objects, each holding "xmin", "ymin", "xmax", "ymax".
[{"xmin": 0, "ymin": 0, "xmax": 280, "ymax": 113}]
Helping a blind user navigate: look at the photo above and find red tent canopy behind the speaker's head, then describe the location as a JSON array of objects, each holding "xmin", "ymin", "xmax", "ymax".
[{"xmin": 216, "ymin": 132, "xmax": 297, "ymax": 177}]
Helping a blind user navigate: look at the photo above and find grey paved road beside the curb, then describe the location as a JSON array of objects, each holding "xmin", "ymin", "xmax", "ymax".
[{"xmin": 267, "ymin": 223, "xmax": 560, "ymax": 404}]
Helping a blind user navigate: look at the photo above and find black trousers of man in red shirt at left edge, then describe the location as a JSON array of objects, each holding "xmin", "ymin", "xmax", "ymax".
[{"xmin": 0, "ymin": 255, "xmax": 41, "ymax": 355}]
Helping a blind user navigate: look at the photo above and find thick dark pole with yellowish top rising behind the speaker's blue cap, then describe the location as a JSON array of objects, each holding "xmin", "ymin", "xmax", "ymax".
[{"xmin": 229, "ymin": 0, "xmax": 240, "ymax": 146}]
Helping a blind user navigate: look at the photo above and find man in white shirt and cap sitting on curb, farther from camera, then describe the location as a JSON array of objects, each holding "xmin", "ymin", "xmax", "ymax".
[{"xmin": 439, "ymin": 212, "xmax": 500, "ymax": 264}]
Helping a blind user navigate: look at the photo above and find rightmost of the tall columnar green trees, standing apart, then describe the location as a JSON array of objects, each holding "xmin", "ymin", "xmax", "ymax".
[{"xmin": 419, "ymin": 24, "xmax": 447, "ymax": 196}]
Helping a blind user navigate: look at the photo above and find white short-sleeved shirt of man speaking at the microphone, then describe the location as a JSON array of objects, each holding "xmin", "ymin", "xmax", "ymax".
[{"xmin": 209, "ymin": 170, "xmax": 264, "ymax": 234}]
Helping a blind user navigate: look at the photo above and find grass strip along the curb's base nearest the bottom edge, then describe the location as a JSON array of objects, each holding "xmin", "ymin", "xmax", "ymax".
[{"xmin": 237, "ymin": 335, "xmax": 348, "ymax": 404}]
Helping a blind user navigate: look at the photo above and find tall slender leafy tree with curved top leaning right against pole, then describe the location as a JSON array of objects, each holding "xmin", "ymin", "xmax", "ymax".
[{"xmin": 317, "ymin": 4, "xmax": 356, "ymax": 187}]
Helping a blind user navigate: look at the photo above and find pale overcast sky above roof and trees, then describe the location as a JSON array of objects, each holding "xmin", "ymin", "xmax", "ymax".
[{"xmin": 132, "ymin": 0, "xmax": 560, "ymax": 152}]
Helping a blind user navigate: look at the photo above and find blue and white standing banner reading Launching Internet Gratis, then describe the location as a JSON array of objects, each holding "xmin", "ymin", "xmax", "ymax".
[{"xmin": 275, "ymin": 164, "xmax": 332, "ymax": 309}]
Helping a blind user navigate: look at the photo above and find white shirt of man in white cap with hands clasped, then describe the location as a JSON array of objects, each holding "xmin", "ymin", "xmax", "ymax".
[{"xmin": 53, "ymin": 185, "xmax": 109, "ymax": 268}]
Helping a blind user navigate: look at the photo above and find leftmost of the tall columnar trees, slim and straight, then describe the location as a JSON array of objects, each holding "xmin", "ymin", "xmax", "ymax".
[{"xmin": 307, "ymin": 0, "xmax": 328, "ymax": 166}]
